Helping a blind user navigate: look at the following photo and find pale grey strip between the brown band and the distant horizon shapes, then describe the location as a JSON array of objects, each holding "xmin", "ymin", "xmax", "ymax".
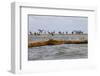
[{"xmin": 29, "ymin": 35, "xmax": 88, "ymax": 41}]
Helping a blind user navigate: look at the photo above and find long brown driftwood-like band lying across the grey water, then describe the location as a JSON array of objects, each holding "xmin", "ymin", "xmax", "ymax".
[{"xmin": 28, "ymin": 39, "xmax": 88, "ymax": 48}]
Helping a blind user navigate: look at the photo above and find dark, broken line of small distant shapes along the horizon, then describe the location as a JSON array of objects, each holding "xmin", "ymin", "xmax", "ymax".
[{"xmin": 29, "ymin": 29, "xmax": 86, "ymax": 36}]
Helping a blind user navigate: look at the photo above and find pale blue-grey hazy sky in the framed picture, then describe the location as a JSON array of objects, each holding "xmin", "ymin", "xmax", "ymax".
[{"xmin": 29, "ymin": 15, "xmax": 88, "ymax": 33}]
